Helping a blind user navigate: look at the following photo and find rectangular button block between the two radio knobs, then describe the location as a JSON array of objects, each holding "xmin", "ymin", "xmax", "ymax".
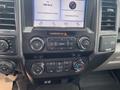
[{"xmin": 47, "ymin": 37, "xmax": 76, "ymax": 51}]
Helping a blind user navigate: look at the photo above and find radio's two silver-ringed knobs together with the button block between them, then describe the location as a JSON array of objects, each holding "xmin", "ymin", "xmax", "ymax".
[{"xmin": 30, "ymin": 37, "xmax": 90, "ymax": 52}]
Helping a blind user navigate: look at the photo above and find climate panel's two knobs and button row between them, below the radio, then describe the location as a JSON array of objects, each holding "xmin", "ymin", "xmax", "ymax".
[{"xmin": 31, "ymin": 59, "xmax": 85, "ymax": 76}]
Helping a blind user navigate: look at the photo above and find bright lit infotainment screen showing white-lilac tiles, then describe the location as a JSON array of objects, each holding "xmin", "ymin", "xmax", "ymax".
[{"xmin": 33, "ymin": 0, "xmax": 85, "ymax": 28}]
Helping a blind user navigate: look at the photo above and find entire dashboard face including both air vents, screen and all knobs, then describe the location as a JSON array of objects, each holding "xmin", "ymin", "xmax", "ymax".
[{"xmin": 0, "ymin": 0, "xmax": 118, "ymax": 84}]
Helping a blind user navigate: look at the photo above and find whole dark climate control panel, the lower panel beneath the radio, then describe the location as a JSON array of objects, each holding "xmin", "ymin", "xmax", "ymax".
[{"xmin": 26, "ymin": 58, "xmax": 88, "ymax": 77}]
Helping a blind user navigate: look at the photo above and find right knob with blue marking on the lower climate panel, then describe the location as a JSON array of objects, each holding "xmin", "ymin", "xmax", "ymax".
[{"xmin": 73, "ymin": 60, "xmax": 84, "ymax": 72}]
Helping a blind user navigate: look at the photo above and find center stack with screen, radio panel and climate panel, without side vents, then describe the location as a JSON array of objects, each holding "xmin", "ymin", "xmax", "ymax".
[{"xmin": 23, "ymin": 0, "xmax": 95, "ymax": 78}]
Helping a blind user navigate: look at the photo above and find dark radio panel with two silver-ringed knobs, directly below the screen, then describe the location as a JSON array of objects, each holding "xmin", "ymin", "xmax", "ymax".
[{"xmin": 23, "ymin": 30, "xmax": 94, "ymax": 54}]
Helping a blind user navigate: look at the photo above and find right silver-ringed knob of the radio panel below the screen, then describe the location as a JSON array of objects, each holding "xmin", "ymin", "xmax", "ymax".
[{"xmin": 78, "ymin": 37, "xmax": 90, "ymax": 50}]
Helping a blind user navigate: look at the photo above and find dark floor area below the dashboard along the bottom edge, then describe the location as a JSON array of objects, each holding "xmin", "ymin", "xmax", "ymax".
[{"xmin": 24, "ymin": 71, "xmax": 120, "ymax": 90}]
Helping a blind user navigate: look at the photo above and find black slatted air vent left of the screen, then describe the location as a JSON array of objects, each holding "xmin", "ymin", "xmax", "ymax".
[{"xmin": 0, "ymin": 0, "xmax": 16, "ymax": 30}]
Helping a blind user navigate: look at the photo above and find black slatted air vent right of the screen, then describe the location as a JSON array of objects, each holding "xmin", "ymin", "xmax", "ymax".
[{"xmin": 101, "ymin": 0, "xmax": 117, "ymax": 31}]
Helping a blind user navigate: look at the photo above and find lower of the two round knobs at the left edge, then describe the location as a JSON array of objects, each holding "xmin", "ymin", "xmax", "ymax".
[{"xmin": 0, "ymin": 61, "xmax": 16, "ymax": 75}]
